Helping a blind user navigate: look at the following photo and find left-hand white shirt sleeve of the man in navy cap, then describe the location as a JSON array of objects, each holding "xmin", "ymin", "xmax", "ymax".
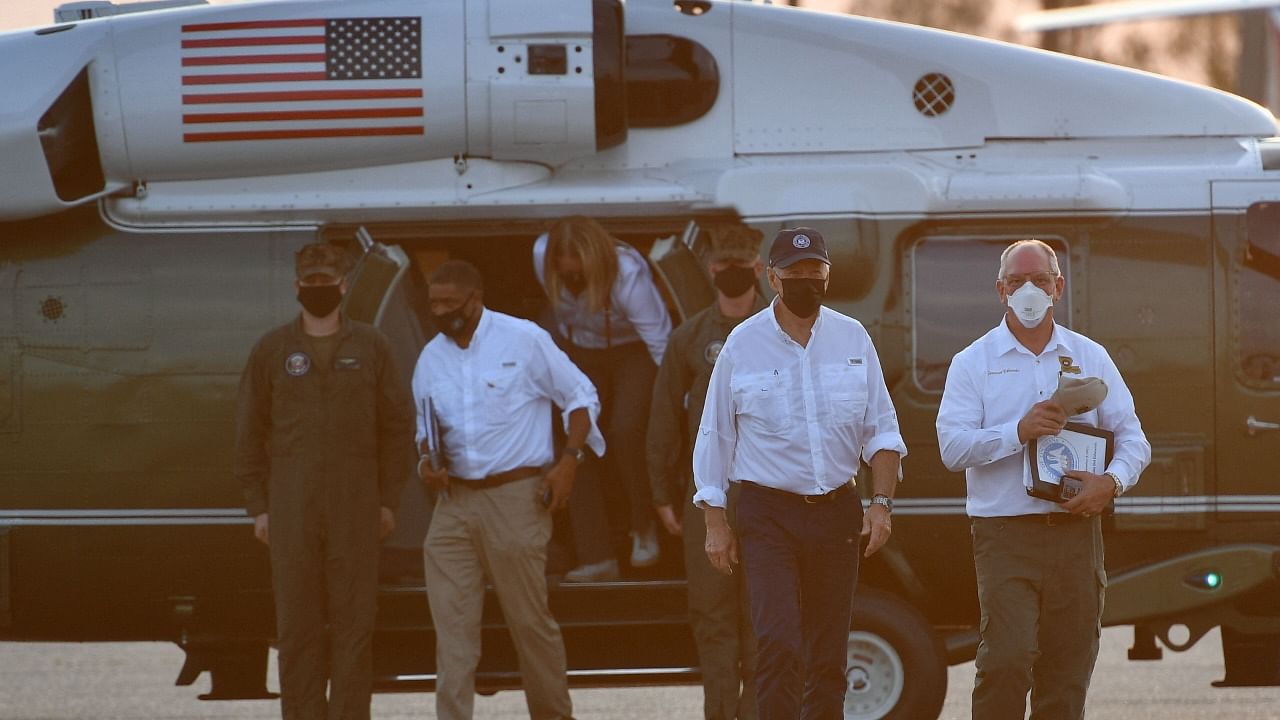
[{"xmin": 694, "ymin": 346, "xmax": 737, "ymax": 507}]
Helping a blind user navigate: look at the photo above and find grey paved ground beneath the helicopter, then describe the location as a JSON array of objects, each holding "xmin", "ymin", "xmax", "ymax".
[{"xmin": 0, "ymin": 629, "xmax": 1280, "ymax": 720}]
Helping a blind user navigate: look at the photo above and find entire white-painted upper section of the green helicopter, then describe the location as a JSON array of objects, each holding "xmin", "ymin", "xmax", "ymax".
[{"xmin": 0, "ymin": 0, "xmax": 1276, "ymax": 224}]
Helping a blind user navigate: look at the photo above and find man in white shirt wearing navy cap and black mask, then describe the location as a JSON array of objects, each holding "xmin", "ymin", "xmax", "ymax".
[{"xmin": 694, "ymin": 228, "xmax": 906, "ymax": 720}]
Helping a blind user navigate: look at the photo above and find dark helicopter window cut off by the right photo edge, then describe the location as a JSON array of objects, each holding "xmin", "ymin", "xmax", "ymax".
[{"xmin": 1234, "ymin": 202, "xmax": 1280, "ymax": 386}]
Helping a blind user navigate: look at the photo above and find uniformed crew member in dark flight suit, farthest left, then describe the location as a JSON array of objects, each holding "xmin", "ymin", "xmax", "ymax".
[{"xmin": 234, "ymin": 243, "xmax": 413, "ymax": 720}]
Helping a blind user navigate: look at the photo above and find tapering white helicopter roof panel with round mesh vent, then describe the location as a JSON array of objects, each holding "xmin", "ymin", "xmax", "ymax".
[{"xmin": 733, "ymin": 0, "xmax": 1276, "ymax": 151}]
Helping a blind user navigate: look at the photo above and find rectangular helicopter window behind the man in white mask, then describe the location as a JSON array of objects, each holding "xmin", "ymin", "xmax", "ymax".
[{"xmin": 908, "ymin": 236, "xmax": 1071, "ymax": 392}]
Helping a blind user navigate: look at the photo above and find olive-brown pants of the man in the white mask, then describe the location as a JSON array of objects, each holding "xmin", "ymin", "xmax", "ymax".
[{"xmin": 973, "ymin": 515, "xmax": 1107, "ymax": 720}]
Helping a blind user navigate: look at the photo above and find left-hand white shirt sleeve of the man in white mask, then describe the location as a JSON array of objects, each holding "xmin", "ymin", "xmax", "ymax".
[{"xmin": 937, "ymin": 352, "xmax": 1023, "ymax": 471}]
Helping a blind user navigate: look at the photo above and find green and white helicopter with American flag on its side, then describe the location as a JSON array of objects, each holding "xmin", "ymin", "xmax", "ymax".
[{"xmin": 0, "ymin": 0, "xmax": 1280, "ymax": 717}]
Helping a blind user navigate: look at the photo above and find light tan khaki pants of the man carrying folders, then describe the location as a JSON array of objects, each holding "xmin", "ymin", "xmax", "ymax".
[{"xmin": 424, "ymin": 477, "xmax": 573, "ymax": 720}]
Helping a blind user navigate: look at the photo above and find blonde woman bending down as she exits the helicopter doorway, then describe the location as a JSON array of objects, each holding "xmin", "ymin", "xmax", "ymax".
[{"xmin": 534, "ymin": 215, "xmax": 671, "ymax": 582}]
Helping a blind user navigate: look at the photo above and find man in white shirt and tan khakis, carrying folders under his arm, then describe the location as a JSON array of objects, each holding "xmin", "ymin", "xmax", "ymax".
[{"xmin": 413, "ymin": 260, "xmax": 604, "ymax": 720}]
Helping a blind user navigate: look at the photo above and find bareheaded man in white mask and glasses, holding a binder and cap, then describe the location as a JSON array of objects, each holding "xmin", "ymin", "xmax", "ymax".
[{"xmin": 937, "ymin": 240, "xmax": 1151, "ymax": 720}]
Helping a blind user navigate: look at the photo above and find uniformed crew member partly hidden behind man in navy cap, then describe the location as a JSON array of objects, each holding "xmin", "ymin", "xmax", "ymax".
[{"xmin": 648, "ymin": 225, "xmax": 768, "ymax": 720}]
